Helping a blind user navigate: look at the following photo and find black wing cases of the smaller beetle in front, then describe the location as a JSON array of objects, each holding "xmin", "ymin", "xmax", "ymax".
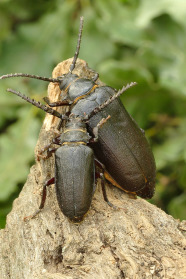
[{"xmin": 55, "ymin": 144, "xmax": 95, "ymax": 222}]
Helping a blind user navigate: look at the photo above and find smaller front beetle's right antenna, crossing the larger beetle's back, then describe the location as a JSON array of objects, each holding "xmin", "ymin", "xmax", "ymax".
[{"xmin": 85, "ymin": 82, "xmax": 137, "ymax": 120}]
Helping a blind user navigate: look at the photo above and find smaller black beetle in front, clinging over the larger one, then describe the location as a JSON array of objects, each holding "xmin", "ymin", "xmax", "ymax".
[{"xmin": 7, "ymin": 83, "xmax": 136, "ymax": 223}]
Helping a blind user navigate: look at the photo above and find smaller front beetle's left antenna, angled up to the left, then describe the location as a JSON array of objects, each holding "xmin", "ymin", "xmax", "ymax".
[{"xmin": 7, "ymin": 88, "xmax": 68, "ymax": 119}]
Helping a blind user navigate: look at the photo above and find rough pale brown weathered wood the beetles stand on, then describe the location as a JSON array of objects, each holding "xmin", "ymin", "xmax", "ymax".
[{"xmin": 0, "ymin": 60, "xmax": 186, "ymax": 279}]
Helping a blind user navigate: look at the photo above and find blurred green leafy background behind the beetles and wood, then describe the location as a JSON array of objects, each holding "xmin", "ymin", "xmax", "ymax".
[{"xmin": 0, "ymin": 0, "xmax": 186, "ymax": 230}]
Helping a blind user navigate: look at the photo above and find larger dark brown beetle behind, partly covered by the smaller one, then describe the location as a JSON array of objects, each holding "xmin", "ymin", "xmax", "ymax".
[{"xmin": 0, "ymin": 17, "xmax": 156, "ymax": 199}]
